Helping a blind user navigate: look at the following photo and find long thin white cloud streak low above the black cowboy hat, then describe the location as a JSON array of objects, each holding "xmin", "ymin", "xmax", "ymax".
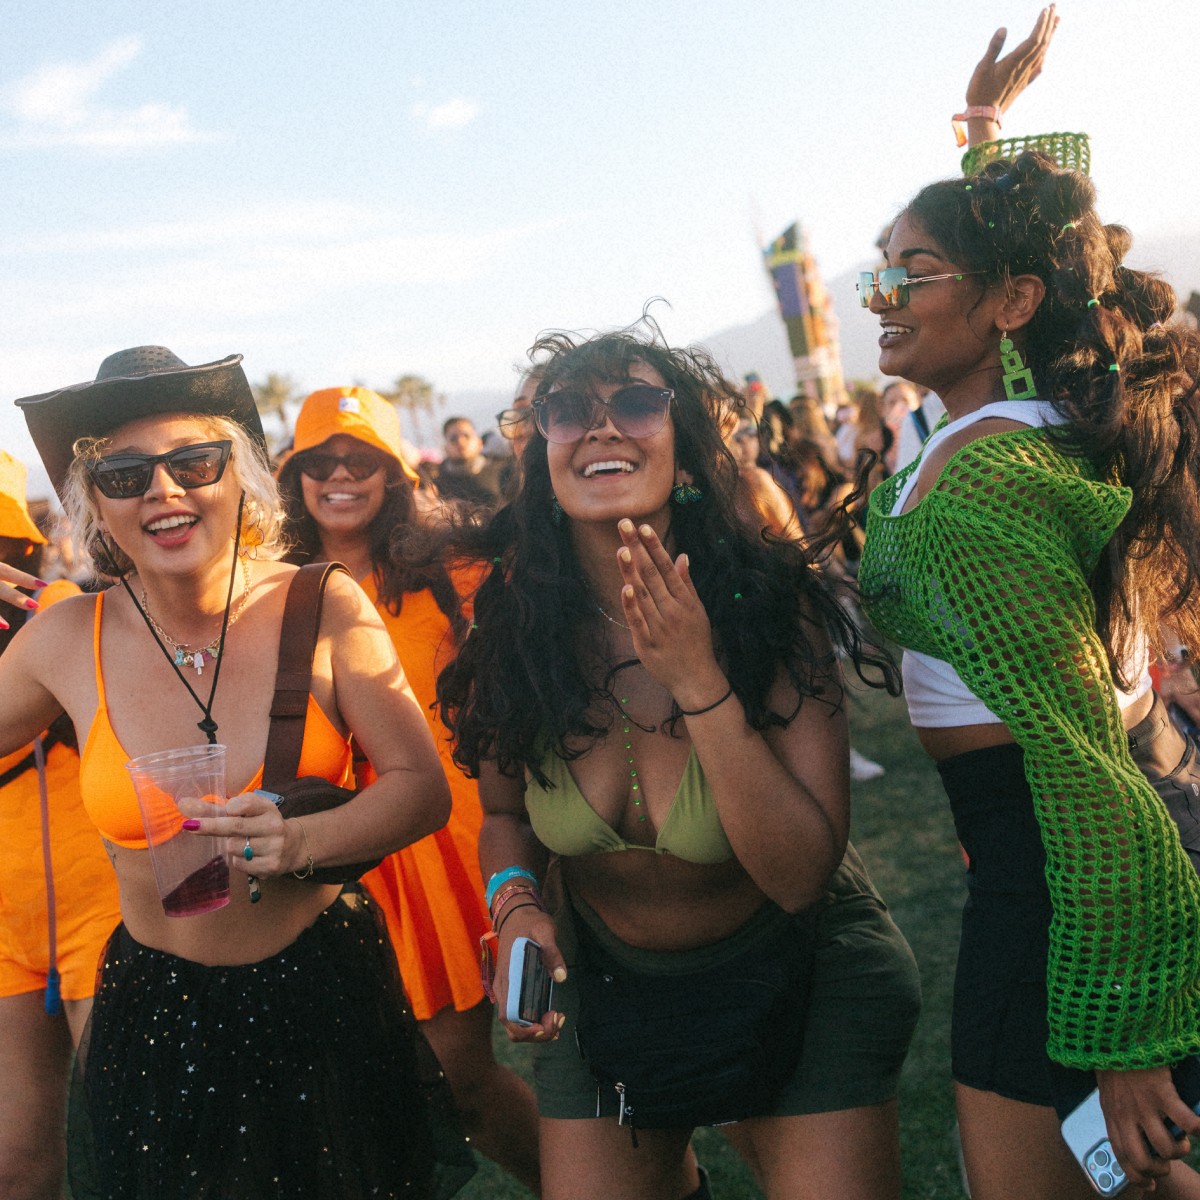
[{"xmin": 0, "ymin": 203, "xmax": 577, "ymax": 331}]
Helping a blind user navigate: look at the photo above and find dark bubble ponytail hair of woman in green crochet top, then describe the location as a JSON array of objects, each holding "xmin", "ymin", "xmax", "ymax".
[{"xmin": 906, "ymin": 152, "xmax": 1200, "ymax": 683}]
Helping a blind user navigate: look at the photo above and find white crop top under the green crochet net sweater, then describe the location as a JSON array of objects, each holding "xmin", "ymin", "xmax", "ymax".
[{"xmin": 892, "ymin": 400, "xmax": 1151, "ymax": 728}]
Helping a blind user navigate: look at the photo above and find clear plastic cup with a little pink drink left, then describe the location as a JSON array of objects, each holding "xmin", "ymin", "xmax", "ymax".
[{"xmin": 125, "ymin": 745, "xmax": 229, "ymax": 917}]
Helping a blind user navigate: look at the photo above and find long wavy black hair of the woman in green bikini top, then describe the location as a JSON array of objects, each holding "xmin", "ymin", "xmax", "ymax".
[{"xmin": 438, "ymin": 317, "xmax": 895, "ymax": 781}]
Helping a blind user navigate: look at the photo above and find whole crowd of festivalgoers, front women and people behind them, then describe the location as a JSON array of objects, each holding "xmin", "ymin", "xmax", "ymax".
[{"xmin": 7, "ymin": 5, "xmax": 1200, "ymax": 1200}]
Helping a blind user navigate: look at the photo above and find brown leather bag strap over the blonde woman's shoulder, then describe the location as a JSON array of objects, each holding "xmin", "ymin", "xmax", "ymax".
[{"xmin": 263, "ymin": 563, "xmax": 349, "ymax": 792}]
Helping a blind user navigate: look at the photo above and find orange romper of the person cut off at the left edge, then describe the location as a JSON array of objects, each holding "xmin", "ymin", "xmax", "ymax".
[{"xmin": 0, "ymin": 580, "xmax": 120, "ymax": 1000}]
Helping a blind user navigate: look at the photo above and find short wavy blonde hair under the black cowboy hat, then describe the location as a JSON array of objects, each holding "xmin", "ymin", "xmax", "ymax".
[{"xmin": 62, "ymin": 413, "xmax": 289, "ymax": 576}]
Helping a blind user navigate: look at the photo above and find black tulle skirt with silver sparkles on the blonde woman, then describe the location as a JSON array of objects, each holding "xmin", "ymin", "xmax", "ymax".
[{"xmin": 70, "ymin": 888, "xmax": 474, "ymax": 1200}]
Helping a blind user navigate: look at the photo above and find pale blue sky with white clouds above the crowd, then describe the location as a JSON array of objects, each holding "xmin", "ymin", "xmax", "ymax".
[{"xmin": 0, "ymin": 0, "xmax": 1200, "ymax": 496}]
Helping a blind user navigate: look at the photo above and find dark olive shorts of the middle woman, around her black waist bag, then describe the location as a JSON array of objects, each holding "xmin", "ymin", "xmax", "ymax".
[{"xmin": 534, "ymin": 846, "xmax": 920, "ymax": 1120}]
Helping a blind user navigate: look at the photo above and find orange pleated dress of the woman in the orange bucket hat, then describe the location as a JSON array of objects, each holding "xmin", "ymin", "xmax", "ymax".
[{"xmin": 360, "ymin": 578, "xmax": 492, "ymax": 1021}]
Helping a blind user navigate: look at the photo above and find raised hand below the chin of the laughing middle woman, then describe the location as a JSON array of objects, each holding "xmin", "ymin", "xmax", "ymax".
[{"xmin": 617, "ymin": 520, "xmax": 727, "ymax": 708}]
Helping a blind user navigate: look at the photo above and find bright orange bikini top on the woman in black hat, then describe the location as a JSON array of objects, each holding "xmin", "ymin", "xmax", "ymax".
[{"xmin": 79, "ymin": 593, "xmax": 353, "ymax": 850}]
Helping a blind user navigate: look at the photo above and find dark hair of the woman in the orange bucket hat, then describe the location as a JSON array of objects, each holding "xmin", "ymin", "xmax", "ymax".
[{"xmin": 278, "ymin": 455, "xmax": 467, "ymax": 640}]
